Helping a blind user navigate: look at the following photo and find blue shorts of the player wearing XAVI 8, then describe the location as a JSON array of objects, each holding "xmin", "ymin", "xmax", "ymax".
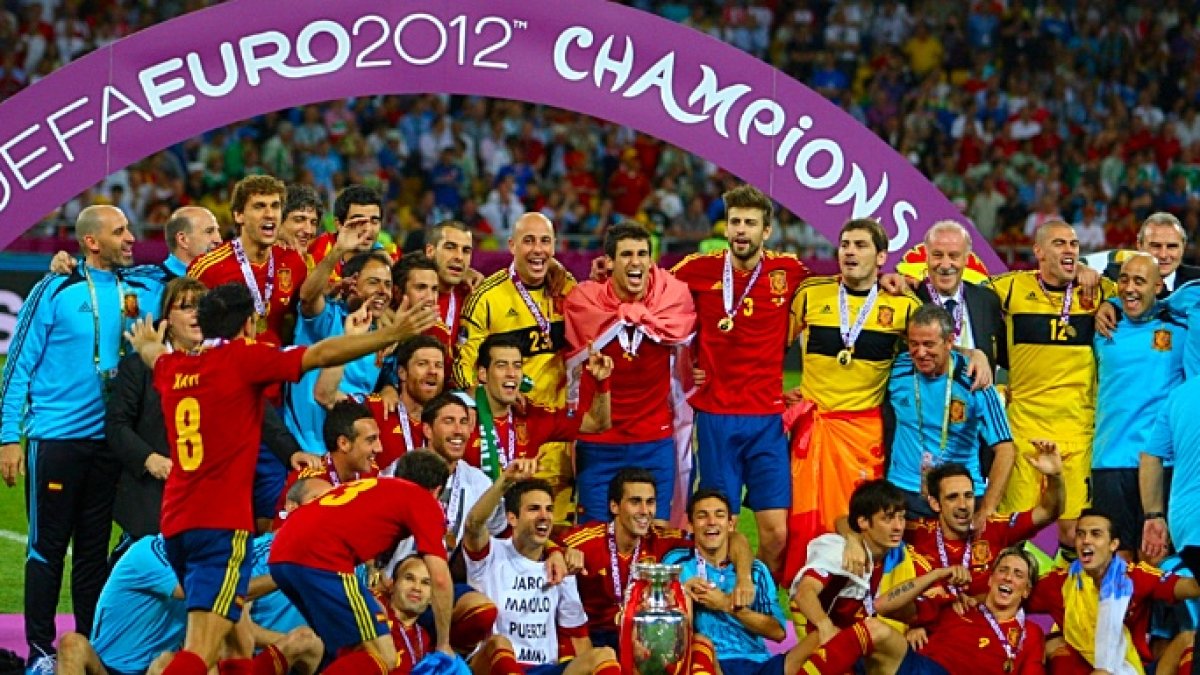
[{"xmin": 164, "ymin": 530, "xmax": 254, "ymax": 622}]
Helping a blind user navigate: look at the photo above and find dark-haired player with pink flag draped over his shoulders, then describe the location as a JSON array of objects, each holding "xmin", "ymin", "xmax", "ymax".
[{"xmin": 563, "ymin": 222, "xmax": 696, "ymax": 524}]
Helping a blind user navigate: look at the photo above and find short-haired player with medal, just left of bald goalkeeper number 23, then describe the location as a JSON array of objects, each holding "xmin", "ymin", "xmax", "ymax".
[{"xmin": 425, "ymin": 220, "xmax": 478, "ymax": 357}]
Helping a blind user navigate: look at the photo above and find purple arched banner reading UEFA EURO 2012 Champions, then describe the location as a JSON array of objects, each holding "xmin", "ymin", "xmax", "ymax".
[{"xmin": 0, "ymin": 0, "xmax": 1004, "ymax": 270}]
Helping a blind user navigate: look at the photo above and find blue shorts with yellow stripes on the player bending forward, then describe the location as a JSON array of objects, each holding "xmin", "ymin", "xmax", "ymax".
[{"xmin": 270, "ymin": 562, "xmax": 390, "ymax": 657}]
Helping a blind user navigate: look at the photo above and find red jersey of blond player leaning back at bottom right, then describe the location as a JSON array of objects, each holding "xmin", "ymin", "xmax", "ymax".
[{"xmin": 920, "ymin": 604, "xmax": 1045, "ymax": 675}]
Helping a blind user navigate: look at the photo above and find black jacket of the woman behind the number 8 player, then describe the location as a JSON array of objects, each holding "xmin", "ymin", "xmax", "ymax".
[{"xmin": 104, "ymin": 353, "xmax": 300, "ymax": 539}]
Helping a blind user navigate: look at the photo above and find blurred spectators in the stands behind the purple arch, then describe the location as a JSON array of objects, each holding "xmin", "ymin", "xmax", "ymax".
[{"xmin": 7, "ymin": 0, "xmax": 1200, "ymax": 263}]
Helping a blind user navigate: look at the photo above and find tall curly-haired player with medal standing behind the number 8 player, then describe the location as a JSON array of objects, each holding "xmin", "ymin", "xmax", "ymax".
[{"xmin": 187, "ymin": 175, "xmax": 309, "ymax": 345}]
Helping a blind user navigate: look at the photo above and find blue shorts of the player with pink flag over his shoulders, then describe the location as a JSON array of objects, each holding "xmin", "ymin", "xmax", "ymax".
[{"xmin": 575, "ymin": 436, "xmax": 676, "ymax": 522}]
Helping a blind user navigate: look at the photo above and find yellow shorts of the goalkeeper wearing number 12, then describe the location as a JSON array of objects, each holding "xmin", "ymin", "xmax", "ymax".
[{"xmin": 998, "ymin": 429, "xmax": 1092, "ymax": 520}]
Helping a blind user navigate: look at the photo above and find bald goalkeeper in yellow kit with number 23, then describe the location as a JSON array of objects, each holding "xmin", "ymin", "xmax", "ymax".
[{"xmin": 454, "ymin": 213, "xmax": 575, "ymax": 520}]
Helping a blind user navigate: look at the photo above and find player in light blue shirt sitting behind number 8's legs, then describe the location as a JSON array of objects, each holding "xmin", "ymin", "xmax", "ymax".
[{"xmin": 58, "ymin": 534, "xmax": 322, "ymax": 675}]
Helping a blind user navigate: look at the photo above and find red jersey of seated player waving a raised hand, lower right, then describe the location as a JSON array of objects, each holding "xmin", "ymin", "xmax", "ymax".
[{"xmin": 904, "ymin": 510, "xmax": 1040, "ymax": 596}]
